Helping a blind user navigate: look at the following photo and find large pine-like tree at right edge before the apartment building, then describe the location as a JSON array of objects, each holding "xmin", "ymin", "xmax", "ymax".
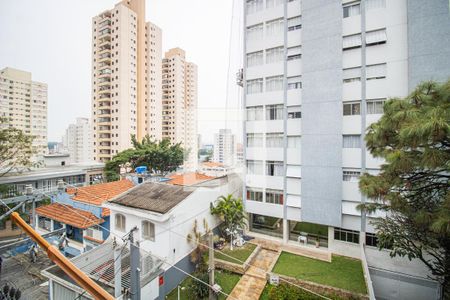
[{"xmin": 359, "ymin": 80, "xmax": 450, "ymax": 299}]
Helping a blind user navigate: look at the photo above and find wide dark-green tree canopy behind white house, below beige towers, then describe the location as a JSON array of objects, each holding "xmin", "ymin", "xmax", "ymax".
[{"xmin": 105, "ymin": 135, "xmax": 185, "ymax": 181}]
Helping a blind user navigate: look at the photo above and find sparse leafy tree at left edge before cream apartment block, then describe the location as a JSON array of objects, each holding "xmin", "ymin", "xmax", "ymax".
[{"xmin": 0, "ymin": 118, "xmax": 35, "ymax": 177}]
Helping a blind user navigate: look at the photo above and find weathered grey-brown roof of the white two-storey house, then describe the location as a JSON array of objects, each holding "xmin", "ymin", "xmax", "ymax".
[{"xmin": 111, "ymin": 182, "xmax": 195, "ymax": 214}]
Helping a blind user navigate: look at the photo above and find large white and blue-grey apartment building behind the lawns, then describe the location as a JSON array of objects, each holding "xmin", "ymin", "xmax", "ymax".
[{"xmin": 243, "ymin": 0, "xmax": 450, "ymax": 299}]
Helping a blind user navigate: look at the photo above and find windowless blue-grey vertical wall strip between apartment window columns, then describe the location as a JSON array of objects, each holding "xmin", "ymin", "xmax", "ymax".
[{"xmin": 301, "ymin": 0, "xmax": 342, "ymax": 226}]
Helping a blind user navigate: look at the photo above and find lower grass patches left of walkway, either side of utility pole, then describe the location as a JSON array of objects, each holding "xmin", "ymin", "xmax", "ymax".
[{"xmin": 166, "ymin": 270, "xmax": 241, "ymax": 300}]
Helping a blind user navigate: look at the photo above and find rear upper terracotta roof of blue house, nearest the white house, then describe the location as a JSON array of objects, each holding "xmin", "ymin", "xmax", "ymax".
[{"xmin": 67, "ymin": 179, "xmax": 134, "ymax": 205}]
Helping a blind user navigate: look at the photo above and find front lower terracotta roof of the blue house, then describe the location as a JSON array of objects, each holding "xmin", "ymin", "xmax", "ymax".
[{"xmin": 36, "ymin": 203, "xmax": 105, "ymax": 229}]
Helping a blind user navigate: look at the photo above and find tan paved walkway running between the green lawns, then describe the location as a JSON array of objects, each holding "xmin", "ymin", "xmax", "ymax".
[{"xmin": 228, "ymin": 249, "xmax": 279, "ymax": 300}]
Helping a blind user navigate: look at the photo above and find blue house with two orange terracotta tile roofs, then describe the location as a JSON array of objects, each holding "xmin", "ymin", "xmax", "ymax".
[{"xmin": 35, "ymin": 179, "xmax": 134, "ymax": 256}]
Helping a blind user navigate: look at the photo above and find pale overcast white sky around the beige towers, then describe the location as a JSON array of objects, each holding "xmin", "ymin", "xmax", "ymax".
[{"xmin": 0, "ymin": 0, "xmax": 242, "ymax": 143}]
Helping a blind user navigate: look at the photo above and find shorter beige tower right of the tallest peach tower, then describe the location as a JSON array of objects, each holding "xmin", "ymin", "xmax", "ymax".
[{"xmin": 162, "ymin": 48, "xmax": 198, "ymax": 170}]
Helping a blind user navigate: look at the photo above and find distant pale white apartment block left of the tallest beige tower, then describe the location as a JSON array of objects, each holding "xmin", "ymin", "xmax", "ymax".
[{"xmin": 63, "ymin": 118, "xmax": 93, "ymax": 163}]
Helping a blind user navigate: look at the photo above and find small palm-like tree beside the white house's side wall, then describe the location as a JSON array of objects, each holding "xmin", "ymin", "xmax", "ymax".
[{"xmin": 210, "ymin": 194, "xmax": 247, "ymax": 246}]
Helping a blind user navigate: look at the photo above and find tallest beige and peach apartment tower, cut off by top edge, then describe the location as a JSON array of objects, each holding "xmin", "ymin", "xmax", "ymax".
[{"xmin": 92, "ymin": 0, "xmax": 162, "ymax": 161}]
